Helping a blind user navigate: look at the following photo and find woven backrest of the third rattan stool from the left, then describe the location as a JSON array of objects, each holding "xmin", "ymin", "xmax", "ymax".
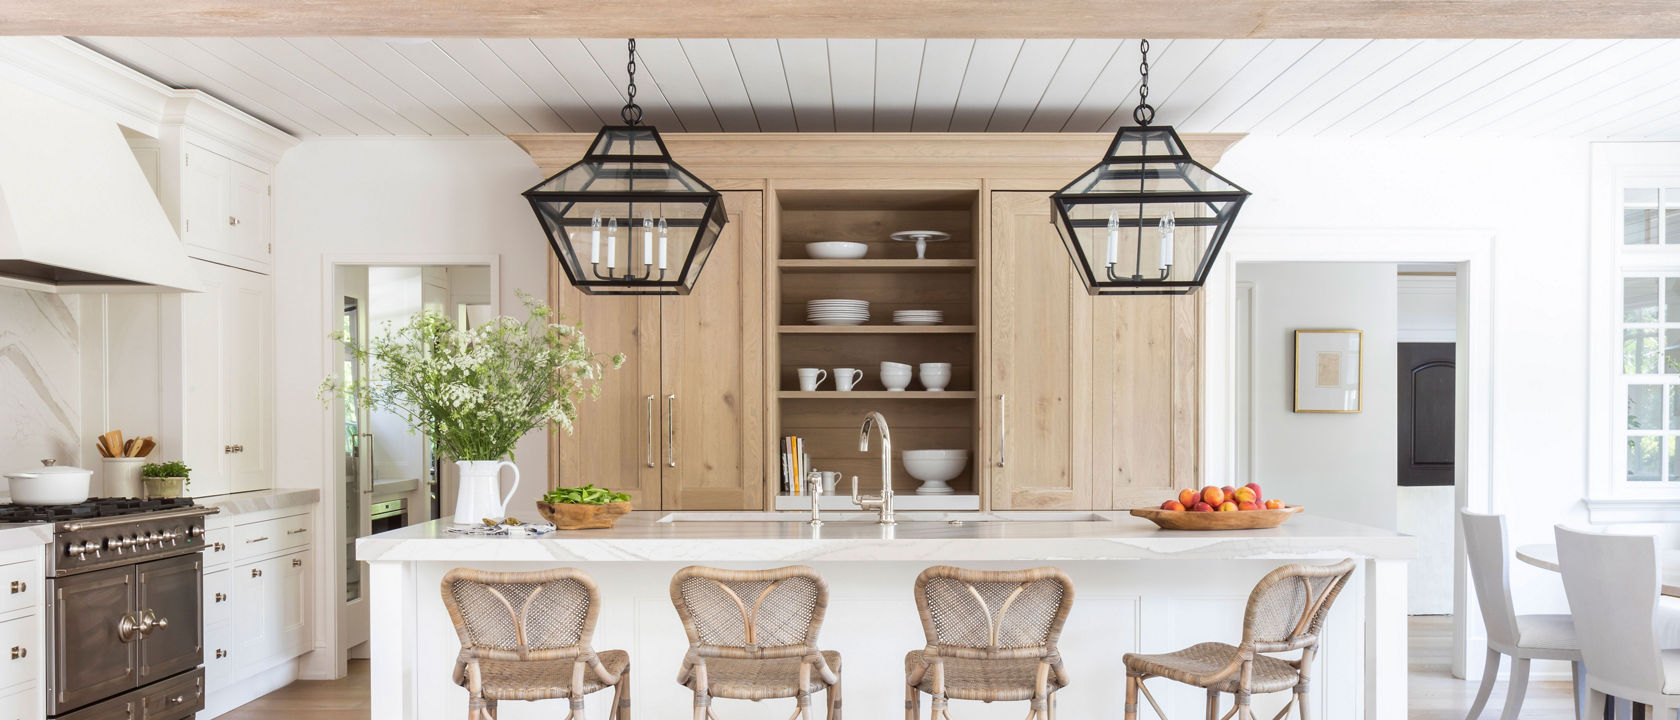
[{"xmin": 916, "ymin": 566, "xmax": 1074, "ymax": 656}]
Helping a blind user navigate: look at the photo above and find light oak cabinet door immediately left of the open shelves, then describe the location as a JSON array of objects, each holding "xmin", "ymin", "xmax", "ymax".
[{"xmin": 657, "ymin": 191, "xmax": 764, "ymax": 510}]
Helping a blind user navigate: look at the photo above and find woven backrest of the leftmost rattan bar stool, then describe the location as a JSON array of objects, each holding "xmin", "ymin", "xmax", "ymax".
[{"xmin": 444, "ymin": 567, "xmax": 600, "ymax": 660}]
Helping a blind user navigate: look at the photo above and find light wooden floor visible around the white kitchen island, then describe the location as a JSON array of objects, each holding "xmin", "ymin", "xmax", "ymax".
[{"xmin": 222, "ymin": 616, "xmax": 1574, "ymax": 720}]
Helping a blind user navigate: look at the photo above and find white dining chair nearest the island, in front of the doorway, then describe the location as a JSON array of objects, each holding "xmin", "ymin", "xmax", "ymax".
[{"xmin": 1458, "ymin": 510, "xmax": 1586, "ymax": 720}]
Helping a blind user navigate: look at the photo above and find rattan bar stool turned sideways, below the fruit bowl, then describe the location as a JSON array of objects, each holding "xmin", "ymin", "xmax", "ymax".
[{"xmin": 1126, "ymin": 559, "xmax": 1356, "ymax": 720}]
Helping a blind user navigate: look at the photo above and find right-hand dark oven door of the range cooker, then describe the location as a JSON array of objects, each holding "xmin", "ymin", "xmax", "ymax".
[{"xmin": 136, "ymin": 552, "xmax": 203, "ymax": 685}]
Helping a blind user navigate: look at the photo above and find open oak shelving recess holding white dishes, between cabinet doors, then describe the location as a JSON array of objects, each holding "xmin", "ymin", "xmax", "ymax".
[{"xmin": 768, "ymin": 188, "xmax": 981, "ymax": 510}]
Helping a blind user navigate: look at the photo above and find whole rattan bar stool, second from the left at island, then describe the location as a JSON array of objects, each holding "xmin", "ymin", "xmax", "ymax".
[{"xmin": 670, "ymin": 566, "xmax": 840, "ymax": 720}]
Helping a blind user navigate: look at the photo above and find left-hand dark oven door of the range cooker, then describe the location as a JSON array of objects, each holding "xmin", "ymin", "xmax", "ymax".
[{"xmin": 49, "ymin": 567, "xmax": 139, "ymax": 715}]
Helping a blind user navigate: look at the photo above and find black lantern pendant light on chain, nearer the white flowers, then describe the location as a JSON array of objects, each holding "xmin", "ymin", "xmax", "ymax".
[{"xmin": 524, "ymin": 39, "xmax": 726, "ymax": 295}]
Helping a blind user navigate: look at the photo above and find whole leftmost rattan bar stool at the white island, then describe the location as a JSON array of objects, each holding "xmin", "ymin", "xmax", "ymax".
[{"xmin": 444, "ymin": 567, "xmax": 630, "ymax": 720}]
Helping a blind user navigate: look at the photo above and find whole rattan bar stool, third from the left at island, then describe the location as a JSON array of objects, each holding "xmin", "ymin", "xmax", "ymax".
[{"xmin": 904, "ymin": 566, "xmax": 1074, "ymax": 720}]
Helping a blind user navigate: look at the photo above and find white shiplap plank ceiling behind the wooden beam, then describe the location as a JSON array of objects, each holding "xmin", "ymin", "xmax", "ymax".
[{"xmin": 79, "ymin": 37, "xmax": 1680, "ymax": 139}]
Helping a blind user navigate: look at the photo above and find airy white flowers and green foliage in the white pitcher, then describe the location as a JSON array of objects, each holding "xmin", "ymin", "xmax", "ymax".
[{"xmin": 321, "ymin": 292, "xmax": 625, "ymax": 460}]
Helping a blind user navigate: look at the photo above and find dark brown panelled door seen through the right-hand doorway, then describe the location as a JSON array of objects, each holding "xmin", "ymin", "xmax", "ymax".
[{"xmin": 1396, "ymin": 342, "xmax": 1457, "ymax": 485}]
